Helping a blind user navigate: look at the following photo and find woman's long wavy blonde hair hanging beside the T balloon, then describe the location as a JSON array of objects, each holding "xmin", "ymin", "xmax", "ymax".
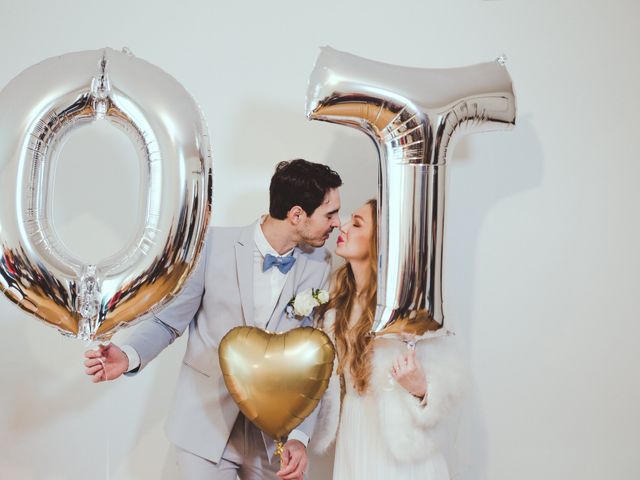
[{"xmin": 323, "ymin": 199, "xmax": 378, "ymax": 394}]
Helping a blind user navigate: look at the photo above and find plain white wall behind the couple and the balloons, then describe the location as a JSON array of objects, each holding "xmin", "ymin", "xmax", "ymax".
[{"xmin": 0, "ymin": 0, "xmax": 640, "ymax": 480}]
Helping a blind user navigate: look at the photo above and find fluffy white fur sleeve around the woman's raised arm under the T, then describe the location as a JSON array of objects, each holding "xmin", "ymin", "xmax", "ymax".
[{"xmin": 373, "ymin": 337, "xmax": 468, "ymax": 462}]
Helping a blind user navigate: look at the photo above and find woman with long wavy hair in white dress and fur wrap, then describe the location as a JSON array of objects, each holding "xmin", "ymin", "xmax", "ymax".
[{"xmin": 313, "ymin": 200, "xmax": 466, "ymax": 480}]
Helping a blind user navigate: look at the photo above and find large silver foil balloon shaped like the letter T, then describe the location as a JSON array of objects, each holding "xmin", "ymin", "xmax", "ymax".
[{"xmin": 306, "ymin": 48, "xmax": 516, "ymax": 338}]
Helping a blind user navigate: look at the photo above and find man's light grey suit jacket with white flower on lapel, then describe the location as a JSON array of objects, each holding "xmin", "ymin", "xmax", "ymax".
[{"xmin": 126, "ymin": 223, "xmax": 331, "ymax": 463}]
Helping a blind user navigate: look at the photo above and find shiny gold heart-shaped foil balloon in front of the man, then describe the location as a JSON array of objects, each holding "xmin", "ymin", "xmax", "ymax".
[{"xmin": 218, "ymin": 327, "xmax": 335, "ymax": 440}]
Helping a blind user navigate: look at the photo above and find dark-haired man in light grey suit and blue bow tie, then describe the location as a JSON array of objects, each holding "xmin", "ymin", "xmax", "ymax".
[{"xmin": 85, "ymin": 159, "xmax": 342, "ymax": 480}]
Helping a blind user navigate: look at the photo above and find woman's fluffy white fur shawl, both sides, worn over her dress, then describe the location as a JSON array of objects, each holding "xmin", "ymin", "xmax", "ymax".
[{"xmin": 310, "ymin": 312, "xmax": 468, "ymax": 462}]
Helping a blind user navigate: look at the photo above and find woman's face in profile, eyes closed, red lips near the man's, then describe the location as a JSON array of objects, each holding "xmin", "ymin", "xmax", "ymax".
[{"xmin": 336, "ymin": 203, "xmax": 373, "ymax": 262}]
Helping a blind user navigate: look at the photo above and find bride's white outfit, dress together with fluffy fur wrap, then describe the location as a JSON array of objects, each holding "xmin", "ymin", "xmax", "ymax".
[{"xmin": 310, "ymin": 311, "xmax": 469, "ymax": 480}]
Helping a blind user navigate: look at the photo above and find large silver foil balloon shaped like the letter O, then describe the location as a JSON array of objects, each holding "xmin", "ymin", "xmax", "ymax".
[{"xmin": 0, "ymin": 49, "xmax": 212, "ymax": 340}]
